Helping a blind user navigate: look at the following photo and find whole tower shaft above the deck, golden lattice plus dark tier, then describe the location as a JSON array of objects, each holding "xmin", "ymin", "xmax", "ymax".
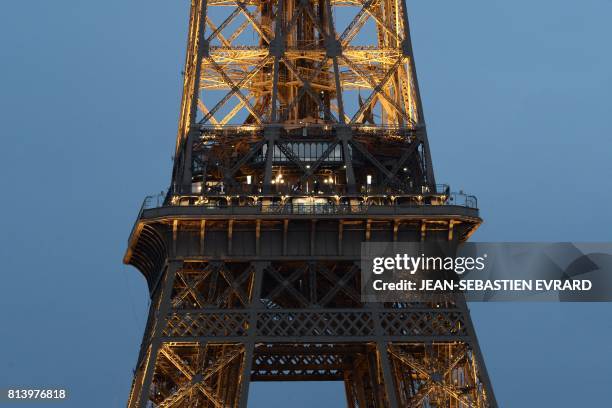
[{"xmin": 172, "ymin": 0, "xmax": 435, "ymax": 196}]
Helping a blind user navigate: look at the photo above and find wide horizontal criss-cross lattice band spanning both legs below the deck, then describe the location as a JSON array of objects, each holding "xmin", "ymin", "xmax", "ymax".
[{"xmin": 162, "ymin": 310, "xmax": 469, "ymax": 341}]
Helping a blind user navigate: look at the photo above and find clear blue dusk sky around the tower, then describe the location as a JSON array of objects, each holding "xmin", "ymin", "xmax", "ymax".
[{"xmin": 0, "ymin": 0, "xmax": 612, "ymax": 408}]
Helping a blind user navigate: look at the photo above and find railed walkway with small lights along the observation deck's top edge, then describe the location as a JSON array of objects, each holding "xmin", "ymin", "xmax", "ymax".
[{"xmin": 130, "ymin": 183, "xmax": 479, "ymax": 231}]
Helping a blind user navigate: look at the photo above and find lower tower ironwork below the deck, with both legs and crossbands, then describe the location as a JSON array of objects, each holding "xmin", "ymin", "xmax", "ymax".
[{"xmin": 129, "ymin": 261, "xmax": 495, "ymax": 408}]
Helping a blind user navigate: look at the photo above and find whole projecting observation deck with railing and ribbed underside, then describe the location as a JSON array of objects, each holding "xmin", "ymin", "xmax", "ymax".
[{"xmin": 124, "ymin": 185, "xmax": 482, "ymax": 289}]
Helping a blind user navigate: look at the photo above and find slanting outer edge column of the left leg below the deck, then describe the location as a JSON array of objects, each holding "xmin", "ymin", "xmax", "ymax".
[{"xmin": 128, "ymin": 260, "xmax": 183, "ymax": 408}]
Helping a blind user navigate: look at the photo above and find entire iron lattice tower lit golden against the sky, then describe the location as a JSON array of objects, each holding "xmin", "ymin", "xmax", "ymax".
[{"xmin": 124, "ymin": 0, "xmax": 497, "ymax": 408}]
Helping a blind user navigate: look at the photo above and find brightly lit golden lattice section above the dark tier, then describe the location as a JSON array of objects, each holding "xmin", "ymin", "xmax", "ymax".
[{"xmin": 179, "ymin": 0, "xmax": 421, "ymax": 135}]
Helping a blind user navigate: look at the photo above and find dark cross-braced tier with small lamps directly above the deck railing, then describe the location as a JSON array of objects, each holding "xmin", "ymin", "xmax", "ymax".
[{"xmin": 184, "ymin": 123, "xmax": 428, "ymax": 197}]
